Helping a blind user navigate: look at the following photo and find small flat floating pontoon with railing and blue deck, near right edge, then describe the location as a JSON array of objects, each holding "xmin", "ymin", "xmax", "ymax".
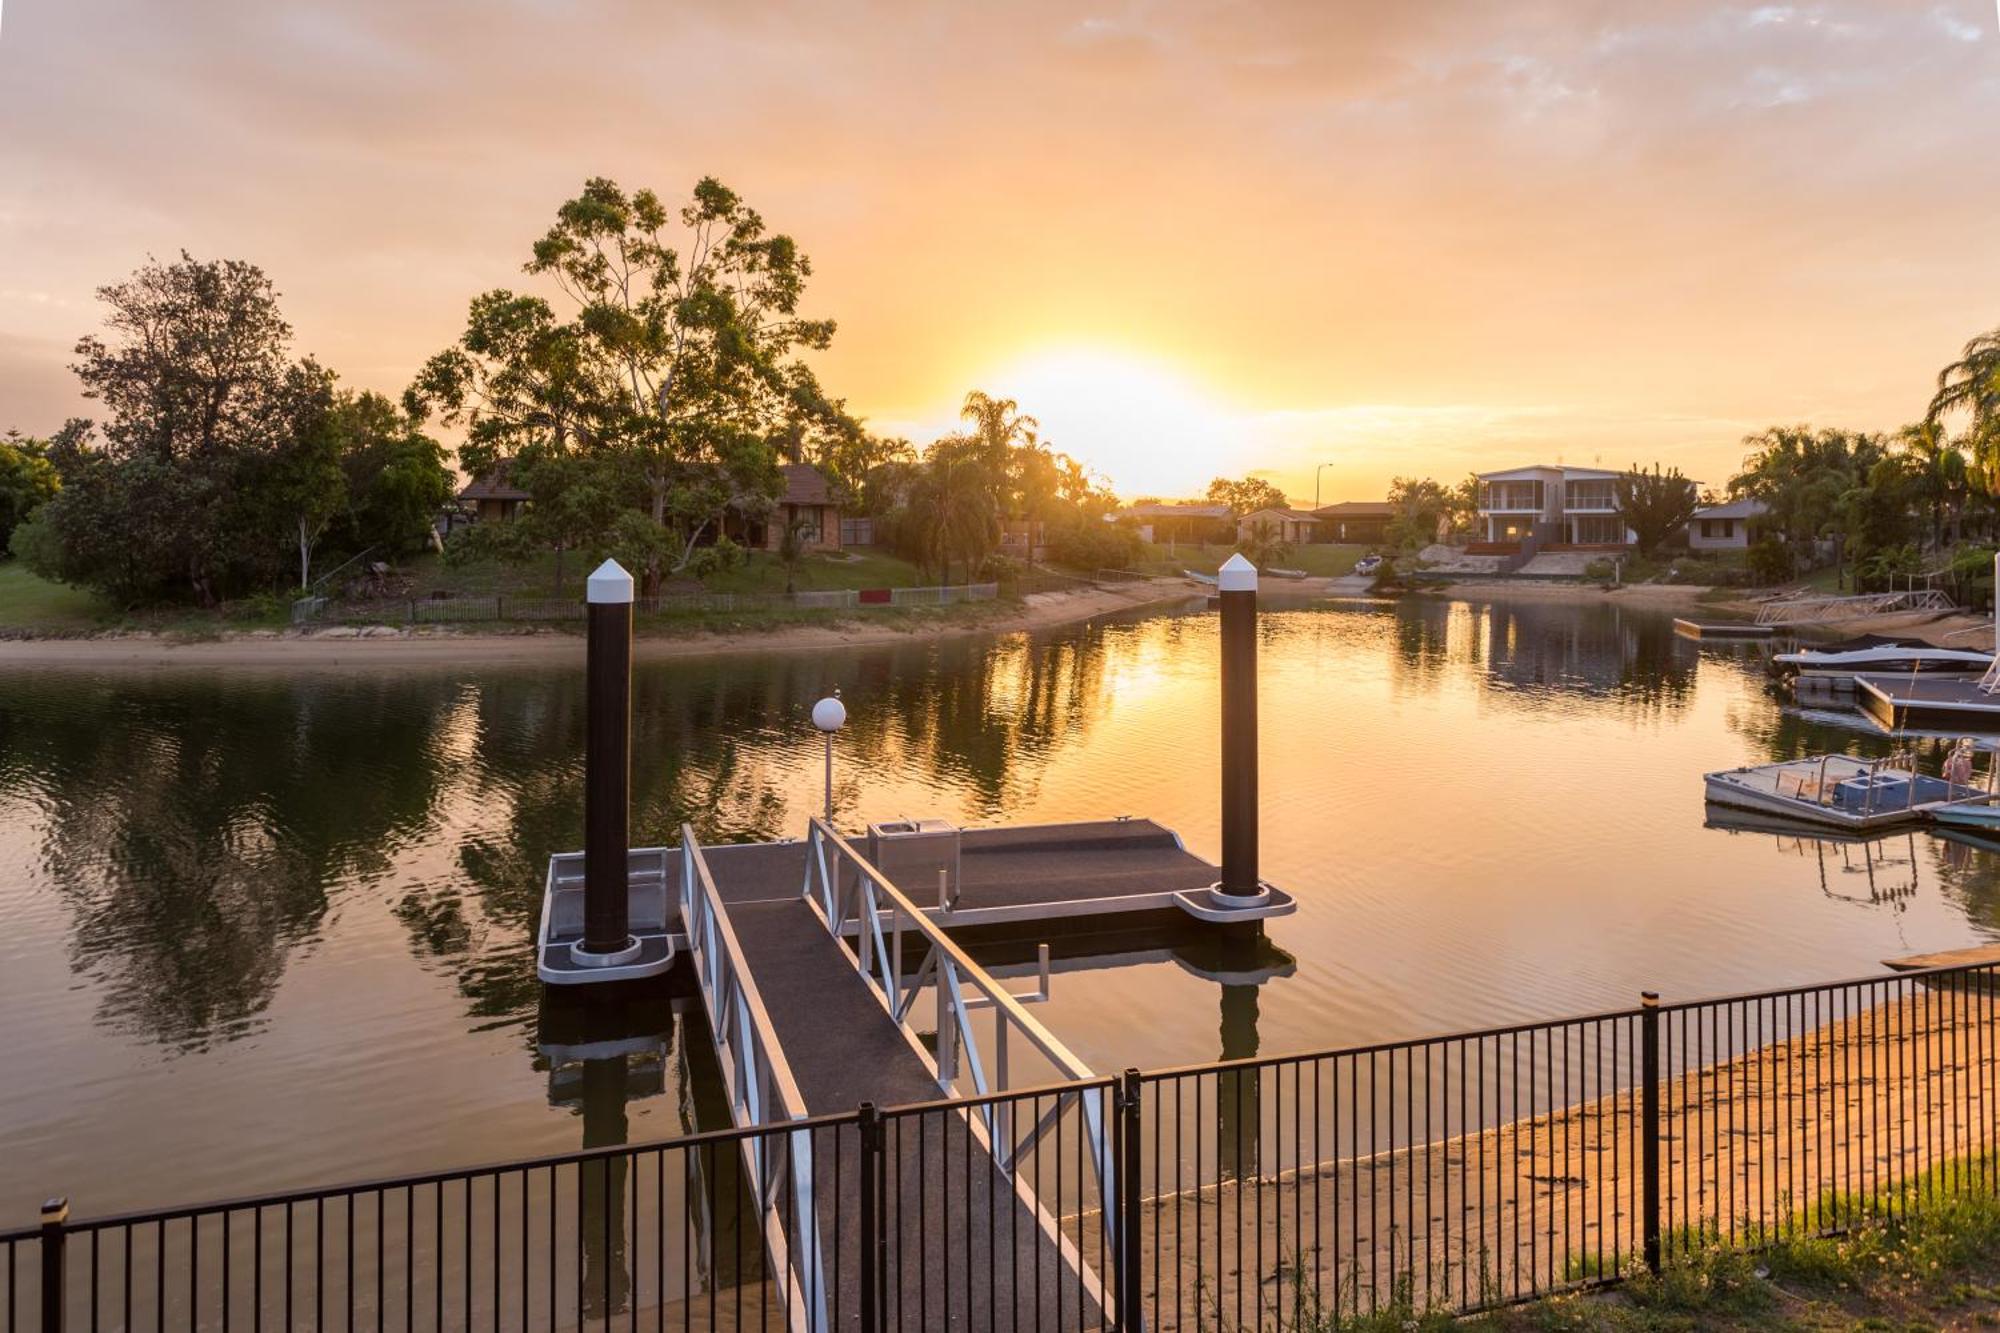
[{"xmin": 1702, "ymin": 755, "xmax": 1994, "ymax": 831}]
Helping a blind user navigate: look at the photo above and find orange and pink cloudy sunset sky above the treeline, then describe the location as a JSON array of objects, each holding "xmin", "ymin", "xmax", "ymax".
[{"xmin": 0, "ymin": 0, "xmax": 2000, "ymax": 500}]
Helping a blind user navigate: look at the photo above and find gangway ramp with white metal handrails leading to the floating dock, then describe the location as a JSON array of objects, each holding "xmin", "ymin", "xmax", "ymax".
[{"xmin": 680, "ymin": 821, "xmax": 1128, "ymax": 1333}]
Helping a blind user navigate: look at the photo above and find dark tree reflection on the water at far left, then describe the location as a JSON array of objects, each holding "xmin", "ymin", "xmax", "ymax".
[{"xmin": 0, "ymin": 673, "xmax": 458, "ymax": 1051}]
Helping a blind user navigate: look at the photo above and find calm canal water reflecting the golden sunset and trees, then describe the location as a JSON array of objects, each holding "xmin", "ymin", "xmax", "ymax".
[{"xmin": 0, "ymin": 602, "xmax": 2000, "ymax": 1225}]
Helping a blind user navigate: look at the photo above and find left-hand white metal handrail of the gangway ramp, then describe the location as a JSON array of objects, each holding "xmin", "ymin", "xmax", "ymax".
[{"xmin": 680, "ymin": 825, "xmax": 832, "ymax": 1333}]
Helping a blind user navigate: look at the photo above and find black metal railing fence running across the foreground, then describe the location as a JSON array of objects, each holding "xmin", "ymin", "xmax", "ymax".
[{"xmin": 0, "ymin": 967, "xmax": 2000, "ymax": 1331}]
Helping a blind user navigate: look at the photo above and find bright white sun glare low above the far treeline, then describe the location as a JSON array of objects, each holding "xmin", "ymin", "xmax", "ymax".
[{"xmin": 982, "ymin": 348, "xmax": 1238, "ymax": 496}]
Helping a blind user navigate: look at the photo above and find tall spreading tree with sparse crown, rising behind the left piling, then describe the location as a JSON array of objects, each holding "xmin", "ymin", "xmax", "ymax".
[{"xmin": 406, "ymin": 178, "xmax": 852, "ymax": 588}]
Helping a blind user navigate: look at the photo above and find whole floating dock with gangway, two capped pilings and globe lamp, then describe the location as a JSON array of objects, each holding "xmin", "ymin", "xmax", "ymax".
[{"xmin": 538, "ymin": 556, "xmax": 1296, "ymax": 1333}]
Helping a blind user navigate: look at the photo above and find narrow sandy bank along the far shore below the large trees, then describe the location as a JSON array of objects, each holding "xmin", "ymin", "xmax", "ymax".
[{"xmin": 0, "ymin": 578, "xmax": 1196, "ymax": 671}]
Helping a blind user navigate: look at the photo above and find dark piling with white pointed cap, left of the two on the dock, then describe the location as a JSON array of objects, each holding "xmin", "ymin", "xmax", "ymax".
[{"xmin": 576, "ymin": 560, "xmax": 638, "ymax": 965}]
